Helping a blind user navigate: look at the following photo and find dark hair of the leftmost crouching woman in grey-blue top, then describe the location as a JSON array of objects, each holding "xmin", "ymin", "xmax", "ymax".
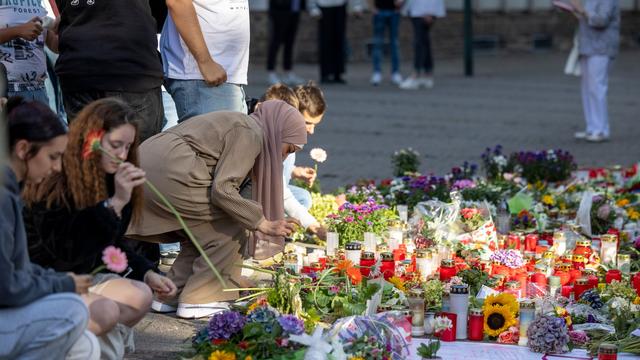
[{"xmin": 7, "ymin": 96, "xmax": 67, "ymax": 159}]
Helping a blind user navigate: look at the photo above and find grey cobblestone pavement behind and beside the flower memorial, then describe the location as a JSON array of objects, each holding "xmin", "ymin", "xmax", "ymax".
[{"xmin": 127, "ymin": 51, "xmax": 640, "ymax": 360}]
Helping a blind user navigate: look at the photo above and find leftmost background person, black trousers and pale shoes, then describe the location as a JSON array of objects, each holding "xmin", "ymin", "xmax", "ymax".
[{"xmin": 267, "ymin": 0, "xmax": 305, "ymax": 85}]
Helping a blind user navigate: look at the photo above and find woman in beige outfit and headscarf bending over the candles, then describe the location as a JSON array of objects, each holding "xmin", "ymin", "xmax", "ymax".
[{"xmin": 128, "ymin": 101, "xmax": 307, "ymax": 318}]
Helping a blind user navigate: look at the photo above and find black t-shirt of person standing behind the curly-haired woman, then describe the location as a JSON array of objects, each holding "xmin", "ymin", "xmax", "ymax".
[{"xmin": 56, "ymin": 0, "xmax": 162, "ymax": 92}]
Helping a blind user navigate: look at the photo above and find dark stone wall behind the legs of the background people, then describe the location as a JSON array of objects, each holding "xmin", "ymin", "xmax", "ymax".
[{"xmin": 251, "ymin": 8, "xmax": 640, "ymax": 63}]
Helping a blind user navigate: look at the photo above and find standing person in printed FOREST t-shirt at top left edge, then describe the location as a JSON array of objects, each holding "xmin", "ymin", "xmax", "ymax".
[{"xmin": 0, "ymin": 1, "xmax": 58, "ymax": 105}]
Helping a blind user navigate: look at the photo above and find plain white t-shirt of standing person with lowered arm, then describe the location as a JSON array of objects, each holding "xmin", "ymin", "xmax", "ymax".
[{"xmin": 160, "ymin": 0, "xmax": 250, "ymax": 85}]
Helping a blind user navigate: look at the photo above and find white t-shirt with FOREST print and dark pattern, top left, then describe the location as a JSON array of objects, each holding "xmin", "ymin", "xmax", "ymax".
[{"xmin": 0, "ymin": 0, "xmax": 47, "ymax": 91}]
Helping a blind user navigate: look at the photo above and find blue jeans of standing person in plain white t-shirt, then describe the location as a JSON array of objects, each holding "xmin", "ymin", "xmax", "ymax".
[{"xmin": 165, "ymin": 79, "xmax": 247, "ymax": 123}]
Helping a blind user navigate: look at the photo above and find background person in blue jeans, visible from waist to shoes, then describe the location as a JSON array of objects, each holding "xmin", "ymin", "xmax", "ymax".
[{"xmin": 371, "ymin": 0, "xmax": 403, "ymax": 86}]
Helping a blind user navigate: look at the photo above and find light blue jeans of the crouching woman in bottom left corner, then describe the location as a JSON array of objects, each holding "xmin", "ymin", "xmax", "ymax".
[{"xmin": 0, "ymin": 293, "xmax": 89, "ymax": 360}]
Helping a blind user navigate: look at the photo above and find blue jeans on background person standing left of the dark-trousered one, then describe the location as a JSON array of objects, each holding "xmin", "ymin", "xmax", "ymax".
[{"xmin": 373, "ymin": 10, "xmax": 400, "ymax": 73}]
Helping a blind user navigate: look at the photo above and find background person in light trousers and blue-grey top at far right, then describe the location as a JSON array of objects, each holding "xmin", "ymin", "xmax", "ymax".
[{"xmin": 571, "ymin": 0, "xmax": 620, "ymax": 142}]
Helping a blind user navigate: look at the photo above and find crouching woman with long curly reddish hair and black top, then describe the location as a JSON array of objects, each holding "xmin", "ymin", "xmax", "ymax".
[{"xmin": 24, "ymin": 99, "xmax": 176, "ymax": 358}]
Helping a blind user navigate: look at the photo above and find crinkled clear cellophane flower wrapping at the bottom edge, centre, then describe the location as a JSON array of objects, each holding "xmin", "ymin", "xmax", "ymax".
[{"xmin": 324, "ymin": 311, "xmax": 411, "ymax": 360}]
